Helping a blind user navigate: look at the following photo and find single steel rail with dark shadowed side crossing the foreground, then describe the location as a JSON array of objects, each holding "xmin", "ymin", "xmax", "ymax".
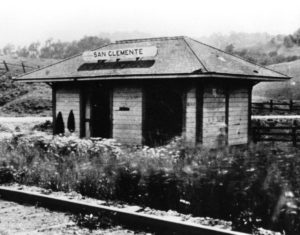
[{"xmin": 0, "ymin": 186, "xmax": 247, "ymax": 235}]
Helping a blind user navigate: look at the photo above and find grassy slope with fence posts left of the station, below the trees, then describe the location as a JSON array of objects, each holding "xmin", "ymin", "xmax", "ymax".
[{"xmin": 0, "ymin": 56, "xmax": 56, "ymax": 116}]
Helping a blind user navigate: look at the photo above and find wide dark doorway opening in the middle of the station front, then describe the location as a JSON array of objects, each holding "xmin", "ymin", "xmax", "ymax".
[{"xmin": 143, "ymin": 84, "xmax": 183, "ymax": 146}]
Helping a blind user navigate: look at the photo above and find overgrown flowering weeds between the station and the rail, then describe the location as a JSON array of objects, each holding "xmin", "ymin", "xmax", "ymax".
[{"xmin": 0, "ymin": 134, "xmax": 300, "ymax": 234}]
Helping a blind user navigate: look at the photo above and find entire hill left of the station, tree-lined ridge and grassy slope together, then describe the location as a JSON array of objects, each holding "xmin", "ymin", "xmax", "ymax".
[{"xmin": 0, "ymin": 35, "xmax": 112, "ymax": 116}]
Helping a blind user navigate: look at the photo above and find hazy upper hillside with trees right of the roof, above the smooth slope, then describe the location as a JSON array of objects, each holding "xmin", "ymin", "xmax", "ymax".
[{"xmin": 199, "ymin": 32, "xmax": 300, "ymax": 66}]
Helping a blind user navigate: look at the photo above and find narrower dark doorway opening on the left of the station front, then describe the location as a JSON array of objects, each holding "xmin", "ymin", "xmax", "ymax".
[{"xmin": 91, "ymin": 85, "xmax": 111, "ymax": 138}]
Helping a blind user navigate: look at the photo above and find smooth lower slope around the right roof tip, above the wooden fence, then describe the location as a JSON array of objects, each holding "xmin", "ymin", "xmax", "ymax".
[{"xmin": 253, "ymin": 60, "xmax": 300, "ymax": 100}]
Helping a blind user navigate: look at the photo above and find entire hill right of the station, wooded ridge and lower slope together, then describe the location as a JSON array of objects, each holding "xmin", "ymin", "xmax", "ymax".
[{"xmin": 199, "ymin": 29, "xmax": 300, "ymax": 100}]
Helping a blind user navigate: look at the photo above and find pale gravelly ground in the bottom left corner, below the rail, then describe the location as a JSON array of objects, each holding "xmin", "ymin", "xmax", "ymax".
[{"xmin": 0, "ymin": 199, "xmax": 145, "ymax": 235}]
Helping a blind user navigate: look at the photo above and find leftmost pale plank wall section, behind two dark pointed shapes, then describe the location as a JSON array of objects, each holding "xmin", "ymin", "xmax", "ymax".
[{"xmin": 55, "ymin": 84, "xmax": 80, "ymax": 135}]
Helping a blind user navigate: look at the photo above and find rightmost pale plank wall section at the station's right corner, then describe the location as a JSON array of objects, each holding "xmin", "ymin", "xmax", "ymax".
[{"xmin": 228, "ymin": 88, "xmax": 250, "ymax": 145}]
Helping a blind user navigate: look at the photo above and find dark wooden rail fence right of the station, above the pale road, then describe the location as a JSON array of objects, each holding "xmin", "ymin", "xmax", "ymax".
[{"xmin": 252, "ymin": 100, "xmax": 300, "ymax": 112}]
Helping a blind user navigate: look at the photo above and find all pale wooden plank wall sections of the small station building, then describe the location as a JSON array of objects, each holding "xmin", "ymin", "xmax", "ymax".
[{"xmin": 54, "ymin": 81, "xmax": 249, "ymax": 147}]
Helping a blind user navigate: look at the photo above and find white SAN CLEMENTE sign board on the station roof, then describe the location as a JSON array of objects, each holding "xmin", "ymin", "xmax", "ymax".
[{"xmin": 82, "ymin": 46, "xmax": 157, "ymax": 62}]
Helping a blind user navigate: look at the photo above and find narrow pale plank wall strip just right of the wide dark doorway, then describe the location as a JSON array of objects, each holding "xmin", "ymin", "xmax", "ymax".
[{"xmin": 185, "ymin": 87, "xmax": 197, "ymax": 145}]
